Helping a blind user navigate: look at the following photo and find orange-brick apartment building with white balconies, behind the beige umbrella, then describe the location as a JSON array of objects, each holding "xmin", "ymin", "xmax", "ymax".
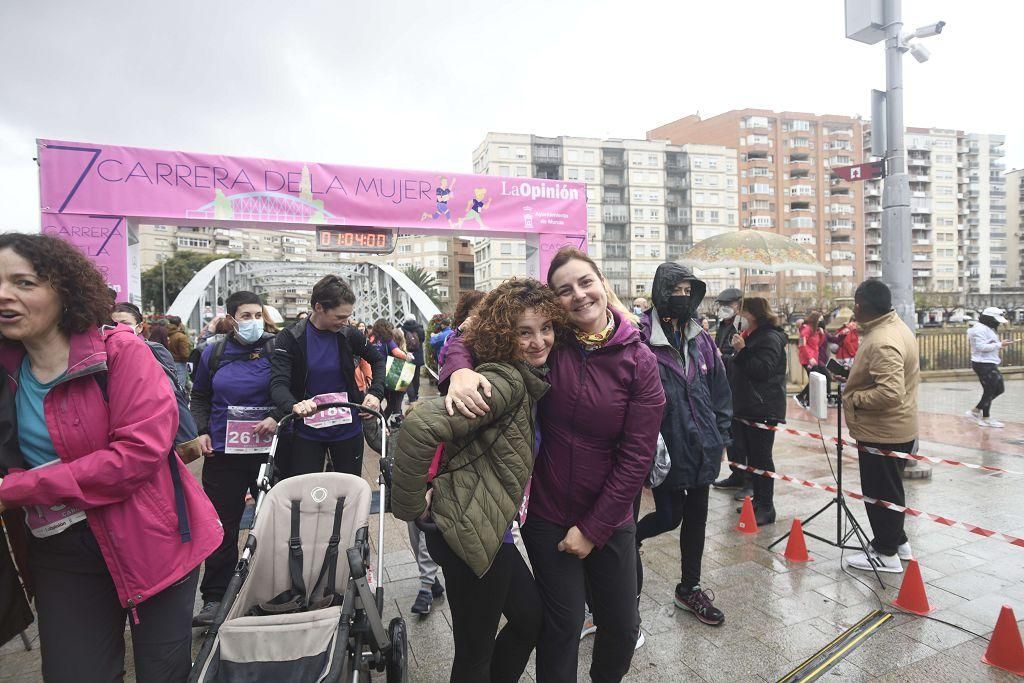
[{"xmin": 647, "ymin": 109, "xmax": 864, "ymax": 308}]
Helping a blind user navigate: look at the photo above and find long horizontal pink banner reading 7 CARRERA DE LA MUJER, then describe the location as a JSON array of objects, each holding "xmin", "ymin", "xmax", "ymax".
[{"xmin": 37, "ymin": 140, "xmax": 587, "ymax": 236}]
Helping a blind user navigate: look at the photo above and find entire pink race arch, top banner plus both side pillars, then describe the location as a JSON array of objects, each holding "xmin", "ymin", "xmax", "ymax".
[{"xmin": 37, "ymin": 139, "xmax": 587, "ymax": 304}]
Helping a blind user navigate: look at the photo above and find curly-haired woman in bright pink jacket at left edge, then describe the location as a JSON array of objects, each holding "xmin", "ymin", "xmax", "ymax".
[{"xmin": 0, "ymin": 233, "xmax": 223, "ymax": 683}]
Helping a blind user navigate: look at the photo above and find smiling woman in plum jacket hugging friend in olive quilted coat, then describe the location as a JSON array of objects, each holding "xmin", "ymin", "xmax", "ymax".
[{"xmin": 440, "ymin": 248, "xmax": 665, "ymax": 683}]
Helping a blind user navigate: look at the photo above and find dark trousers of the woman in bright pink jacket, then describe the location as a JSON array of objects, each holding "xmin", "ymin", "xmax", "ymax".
[{"xmin": 29, "ymin": 522, "xmax": 199, "ymax": 683}]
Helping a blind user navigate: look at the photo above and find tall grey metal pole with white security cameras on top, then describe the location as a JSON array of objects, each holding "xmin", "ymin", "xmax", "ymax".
[{"xmin": 846, "ymin": 0, "xmax": 945, "ymax": 330}]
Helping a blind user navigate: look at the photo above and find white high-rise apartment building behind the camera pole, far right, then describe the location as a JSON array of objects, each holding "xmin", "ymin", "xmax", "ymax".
[{"xmin": 864, "ymin": 125, "xmax": 1016, "ymax": 305}]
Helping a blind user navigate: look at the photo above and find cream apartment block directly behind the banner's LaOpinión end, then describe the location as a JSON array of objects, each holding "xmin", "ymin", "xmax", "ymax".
[{"xmin": 473, "ymin": 133, "xmax": 738, "ymax": 299}]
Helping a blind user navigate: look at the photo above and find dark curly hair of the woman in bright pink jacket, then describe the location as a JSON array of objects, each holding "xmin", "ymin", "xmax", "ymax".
[{"xmin": 0, "ymin": 232, "xmax": 112, "ymax": 335}]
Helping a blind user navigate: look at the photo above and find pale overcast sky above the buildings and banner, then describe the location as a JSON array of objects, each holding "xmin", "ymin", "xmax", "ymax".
[{"xmin": 0, "ymin": 0, "xmax": 1024, "ymax": 230}]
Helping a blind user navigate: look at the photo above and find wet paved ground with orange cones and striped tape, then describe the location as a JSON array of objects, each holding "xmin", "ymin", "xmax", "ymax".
[{"xmin": 0, "ymin": 381, "xmax": 1024, "ymax": 683}]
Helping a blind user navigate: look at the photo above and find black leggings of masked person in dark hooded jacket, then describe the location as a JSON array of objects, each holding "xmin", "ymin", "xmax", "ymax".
[{"xmin": 634, "ymin": 486, "xmax": 711, "ymax": 593}]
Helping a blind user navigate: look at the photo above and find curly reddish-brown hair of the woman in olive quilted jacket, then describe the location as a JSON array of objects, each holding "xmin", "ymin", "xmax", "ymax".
[{"xmin": 464, "ymin": 278, "xmax": 568, "ymax": 362}]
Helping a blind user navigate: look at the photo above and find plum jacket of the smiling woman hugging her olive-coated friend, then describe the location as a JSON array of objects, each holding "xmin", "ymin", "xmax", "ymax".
[{"xmin": 440, "ymin": 311, "xmax": 665, "ymax": 548}]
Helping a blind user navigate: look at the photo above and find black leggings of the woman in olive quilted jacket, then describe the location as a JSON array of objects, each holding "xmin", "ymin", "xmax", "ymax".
[{"xmin": 424, "ymin": 529, "xmax": 544, "ymax": 683}]
